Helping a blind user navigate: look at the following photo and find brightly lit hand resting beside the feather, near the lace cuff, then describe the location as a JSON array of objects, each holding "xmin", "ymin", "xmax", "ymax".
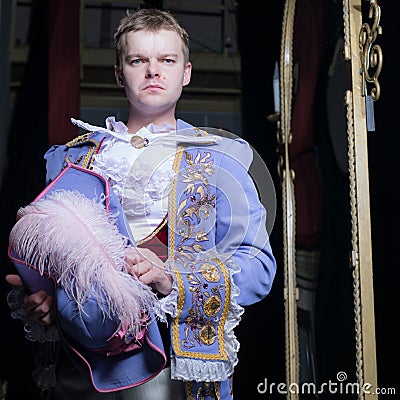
[{"xmin": 125, "ymin": 247, "xmax": 172, "ymax": 295}]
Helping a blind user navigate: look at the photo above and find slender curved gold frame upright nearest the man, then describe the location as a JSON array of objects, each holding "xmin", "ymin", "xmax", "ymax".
[{"xmin": 277, "ymin": 0, "xmax": 300, "ymax": 400}]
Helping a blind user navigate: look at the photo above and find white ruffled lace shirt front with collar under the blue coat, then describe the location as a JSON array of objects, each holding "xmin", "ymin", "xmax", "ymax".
[{"xmin": 82, "ymin": 117, "xmax": 176, "ymax": 241}]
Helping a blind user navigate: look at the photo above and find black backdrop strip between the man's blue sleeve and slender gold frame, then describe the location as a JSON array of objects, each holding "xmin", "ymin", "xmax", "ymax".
[{"xmin": 233, "ymin": 0, "xmax": 286, "ymax": 399}]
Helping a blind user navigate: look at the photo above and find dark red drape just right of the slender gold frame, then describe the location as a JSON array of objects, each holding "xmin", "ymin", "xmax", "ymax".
[{"xmin": 289, "ymin": 0, "xmax": 323, "ymax": 249}]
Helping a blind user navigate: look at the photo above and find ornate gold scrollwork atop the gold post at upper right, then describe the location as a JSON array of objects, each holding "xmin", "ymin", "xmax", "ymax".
[{"xmin": 359, "ymin": 0, "xmax": 383, "ymax": 101}]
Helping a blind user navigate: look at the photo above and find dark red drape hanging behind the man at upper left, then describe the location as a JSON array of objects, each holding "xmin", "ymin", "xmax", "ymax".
[{"xmin": 48, "ymin": 0, "xmax": 80, "ymax": 146}]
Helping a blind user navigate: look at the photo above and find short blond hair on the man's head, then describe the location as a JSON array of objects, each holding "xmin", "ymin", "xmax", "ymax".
[{"xmin": 114, "ymin": 8, "xmax": 189, "ymax": 66}]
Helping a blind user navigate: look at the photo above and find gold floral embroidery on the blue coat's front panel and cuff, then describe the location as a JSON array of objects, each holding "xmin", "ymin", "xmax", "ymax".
[{"xmin": 169, "ymin": 148, "xmax": 230, "ymax": 360}]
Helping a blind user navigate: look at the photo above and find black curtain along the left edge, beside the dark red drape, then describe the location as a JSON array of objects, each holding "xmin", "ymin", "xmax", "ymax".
[{"xmin": 0, "ymin": 0, "xmax": 48, "ymax": 400}]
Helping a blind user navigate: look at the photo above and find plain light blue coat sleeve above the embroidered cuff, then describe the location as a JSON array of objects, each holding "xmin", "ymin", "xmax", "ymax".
[{"xmin": 216, "ymin": 139, "xmax": 276, "ymax": 306}]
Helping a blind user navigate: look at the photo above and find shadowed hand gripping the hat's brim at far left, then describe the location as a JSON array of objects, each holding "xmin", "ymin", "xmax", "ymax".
[{"xmin": 6, "ymin": 274, "xmax": 55, "ymax": 325}]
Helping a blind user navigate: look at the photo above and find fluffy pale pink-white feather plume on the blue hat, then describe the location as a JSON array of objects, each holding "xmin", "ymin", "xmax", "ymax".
[{"xmin": 9, "ymin": 190, "xmax": 157, "ymax": 333}]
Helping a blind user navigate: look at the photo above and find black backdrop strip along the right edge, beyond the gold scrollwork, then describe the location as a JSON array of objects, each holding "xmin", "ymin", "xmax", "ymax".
[{"xmin": 368, "ymin": 0, "xmax": 400, "ymax": 390}]
